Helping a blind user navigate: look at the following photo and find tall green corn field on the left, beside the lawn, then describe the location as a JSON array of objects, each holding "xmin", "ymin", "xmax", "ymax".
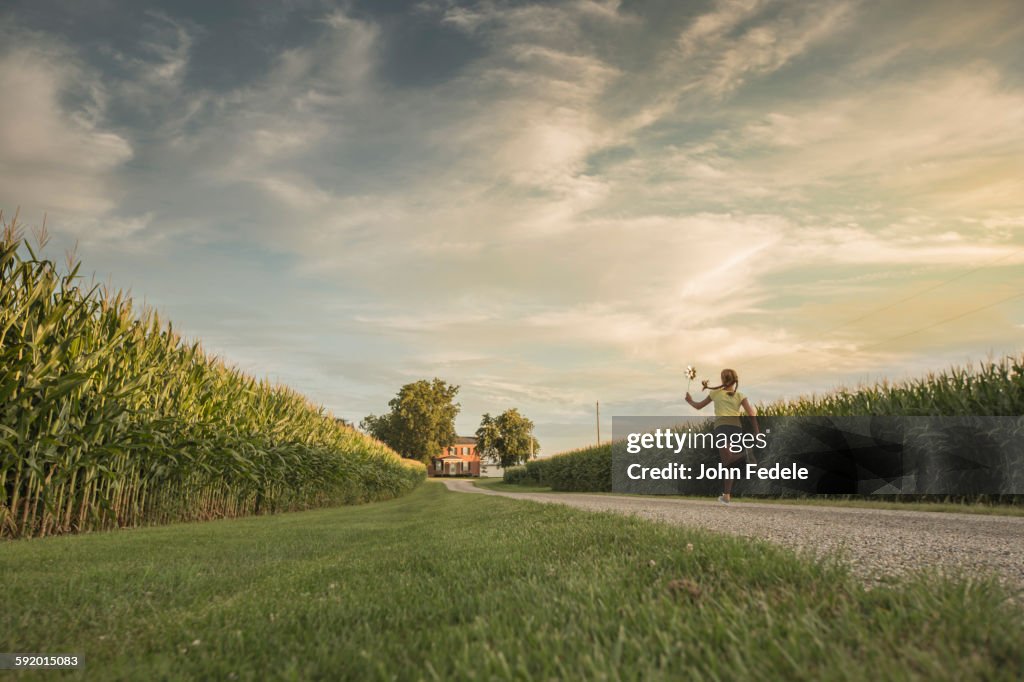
[{"xmin": 0, "ymin": 223, "xmax": 426, "ymax": 538}]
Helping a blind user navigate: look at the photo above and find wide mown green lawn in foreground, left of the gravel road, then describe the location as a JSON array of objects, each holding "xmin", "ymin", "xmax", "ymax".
[{"xmin": 0, "ymin": 483, "xmax": 1024, "ymax": 680}]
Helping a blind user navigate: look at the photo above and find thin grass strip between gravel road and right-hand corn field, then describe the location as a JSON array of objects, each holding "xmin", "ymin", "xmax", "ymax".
[{"xmin": 474, "ymin": 478, "xmax": 1024, "ymax": 516}]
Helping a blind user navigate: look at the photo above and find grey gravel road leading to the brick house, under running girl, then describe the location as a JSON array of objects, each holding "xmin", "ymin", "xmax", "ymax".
[{"xmin": 443, "ymin": 479, "xmax": 1024, "ymax": 590}]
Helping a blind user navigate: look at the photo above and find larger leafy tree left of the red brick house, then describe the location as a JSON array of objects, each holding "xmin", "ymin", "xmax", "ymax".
[{"xmin": 359, "ymin": 378, "xmax": 461, "ymax": 464}]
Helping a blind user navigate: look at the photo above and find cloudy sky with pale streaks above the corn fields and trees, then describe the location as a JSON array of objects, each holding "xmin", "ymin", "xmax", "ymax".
[{"xmin": 0, "ymin": 0, "xmax": 1024, "ymax": 454}]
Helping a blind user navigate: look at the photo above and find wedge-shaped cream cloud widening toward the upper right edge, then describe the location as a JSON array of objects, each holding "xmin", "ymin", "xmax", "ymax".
[{"xmin": 603, "ymin": 62, "xmax": 1024, "ymax": 220}]
